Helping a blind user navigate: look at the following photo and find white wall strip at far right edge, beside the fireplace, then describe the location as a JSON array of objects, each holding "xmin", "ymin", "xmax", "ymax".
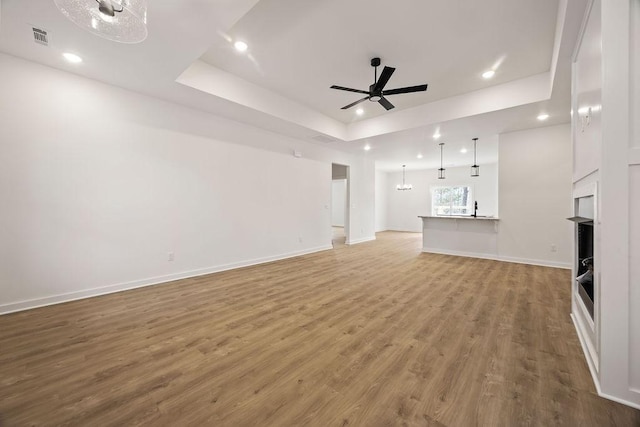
[{"xmin": 597, "ymin": 1, "xmax": 640, "ymax": 409}]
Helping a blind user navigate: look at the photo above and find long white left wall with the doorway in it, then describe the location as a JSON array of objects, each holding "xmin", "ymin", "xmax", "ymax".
[{"xmin": 0, "ymin": 54, "xmax": 375, "ymax": 313}]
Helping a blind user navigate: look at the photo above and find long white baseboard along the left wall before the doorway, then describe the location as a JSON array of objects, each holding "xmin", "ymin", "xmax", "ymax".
[{"xmin": 0, "ymin": 245, "xmax": 333, "ymax": 315}]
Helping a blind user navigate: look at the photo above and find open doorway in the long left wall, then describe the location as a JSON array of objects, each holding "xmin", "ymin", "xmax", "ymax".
[{"xmin": 331, "ymin": 163, "xmax": 349, "ymax": 248}]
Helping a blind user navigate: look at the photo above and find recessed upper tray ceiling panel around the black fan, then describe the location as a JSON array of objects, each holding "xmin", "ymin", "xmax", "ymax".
[{"xmin": 201, "ymin": 0, "xmax": 558, "ymax": 123}]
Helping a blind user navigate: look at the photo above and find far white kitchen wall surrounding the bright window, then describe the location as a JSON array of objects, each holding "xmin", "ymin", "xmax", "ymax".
[{"xmin": 384, "ymin": 163, "xmax": 498, "ymax": 232}]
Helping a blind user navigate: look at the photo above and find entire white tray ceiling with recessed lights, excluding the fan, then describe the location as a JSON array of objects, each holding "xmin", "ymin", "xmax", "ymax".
[{"xmin": 0, "ymin": 0, "xmax": 586, "ymax": 170}]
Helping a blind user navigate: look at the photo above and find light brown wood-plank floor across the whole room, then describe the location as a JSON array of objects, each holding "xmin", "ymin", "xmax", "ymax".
[{"xmin": 0, "ymin": 232, "xmax": 640, "ymax": 427}]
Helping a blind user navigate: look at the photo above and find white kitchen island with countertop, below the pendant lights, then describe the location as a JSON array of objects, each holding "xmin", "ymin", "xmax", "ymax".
[{"xmin": 419, "ymin": 216, "xmax": 499, "ymax": 259}]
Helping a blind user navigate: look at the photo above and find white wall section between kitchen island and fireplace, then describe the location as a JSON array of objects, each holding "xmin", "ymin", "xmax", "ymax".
[{"xmin": 498, "ymin": 124, "xmax": 573, "ymax": 268}]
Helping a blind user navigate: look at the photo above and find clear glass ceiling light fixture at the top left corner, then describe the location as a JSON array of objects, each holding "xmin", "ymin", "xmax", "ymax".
[{"xmin": 54, "ymin": 0, "xmax": 148, "ymax": 43}]
